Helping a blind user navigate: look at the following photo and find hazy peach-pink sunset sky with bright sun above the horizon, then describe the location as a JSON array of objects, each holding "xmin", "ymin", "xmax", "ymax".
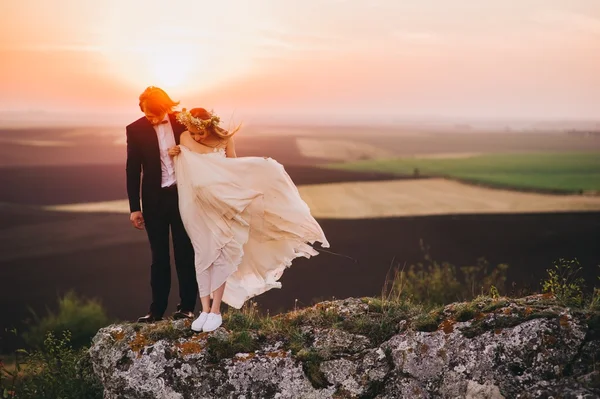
[{"xmin": 0, "ymin": 0, "xmax": 600, "ymax": 121}]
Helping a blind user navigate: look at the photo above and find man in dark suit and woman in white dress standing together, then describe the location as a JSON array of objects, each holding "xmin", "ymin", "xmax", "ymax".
[{"xmin": 126, "ymin": 86, "xmax": 329, "ymax": 331}]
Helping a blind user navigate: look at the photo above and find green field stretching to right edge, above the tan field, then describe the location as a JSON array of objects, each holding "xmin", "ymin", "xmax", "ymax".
[{"xmin": 326, "ymin": 152, "xmax": 600, "ymax": 192}]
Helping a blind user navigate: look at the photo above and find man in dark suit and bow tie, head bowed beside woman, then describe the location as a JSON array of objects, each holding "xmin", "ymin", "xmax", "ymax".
[{"xmin": 126, "ymin": 86, "xmax": 198, "ymax": 323}]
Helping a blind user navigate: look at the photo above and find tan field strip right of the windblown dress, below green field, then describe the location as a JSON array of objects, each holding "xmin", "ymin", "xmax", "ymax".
[{"xmin": 300, "ymin": 179, "xmax": 600, "ymax": 219}]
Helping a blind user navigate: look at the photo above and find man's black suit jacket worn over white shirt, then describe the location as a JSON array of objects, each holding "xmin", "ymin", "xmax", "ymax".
[{"xmin": 125, "ymin": 114, "xmax": 186, "ymax": 212}]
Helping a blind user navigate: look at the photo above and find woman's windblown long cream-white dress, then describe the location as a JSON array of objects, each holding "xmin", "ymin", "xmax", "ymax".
[{"xmin": 175, "ymin": 145, "xmax": 329, "ymax": 309}]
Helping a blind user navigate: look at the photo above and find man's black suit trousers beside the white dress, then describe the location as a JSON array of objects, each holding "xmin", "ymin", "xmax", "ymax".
[{"xmin": 144, "ymin": 187, "xmax": 198, "ymax": 317}]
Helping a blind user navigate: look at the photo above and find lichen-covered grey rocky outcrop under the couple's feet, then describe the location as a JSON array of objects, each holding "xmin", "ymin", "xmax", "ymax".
[{"xmin": 90, "ymin": 296, "xmax": 600, "ymax": 399}]
